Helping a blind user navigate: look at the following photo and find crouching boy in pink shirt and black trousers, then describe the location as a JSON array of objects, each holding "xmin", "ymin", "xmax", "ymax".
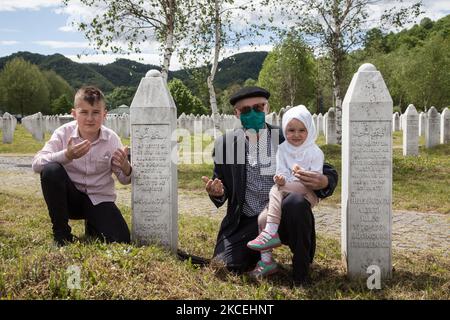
[{"xmin": 32, "ymin": 86, "xmax": 132, "ymax": 245}]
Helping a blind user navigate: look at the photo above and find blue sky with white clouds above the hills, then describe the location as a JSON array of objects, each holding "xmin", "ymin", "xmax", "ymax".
[{"xmin": 0, "ymin": 0, "xmax": 450, "ymax": 70}]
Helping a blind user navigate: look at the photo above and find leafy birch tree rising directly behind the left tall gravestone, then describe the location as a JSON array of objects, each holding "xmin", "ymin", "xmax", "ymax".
[{"xmin": 64, "ymin": 0, "xmax": 195, "ymax": 80}]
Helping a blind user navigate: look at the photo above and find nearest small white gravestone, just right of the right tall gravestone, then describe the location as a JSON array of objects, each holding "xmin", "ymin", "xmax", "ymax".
[{"xmin": 403, "ymin": 104, "xmax": 419, "ymax": 156}]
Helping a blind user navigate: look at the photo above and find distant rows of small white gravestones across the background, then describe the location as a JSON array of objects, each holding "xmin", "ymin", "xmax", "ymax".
[{"xmin": 1, "ymin": 105, "xmax": 450, "ymax": 155}]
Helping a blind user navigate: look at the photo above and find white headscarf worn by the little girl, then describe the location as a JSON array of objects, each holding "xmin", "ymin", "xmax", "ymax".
[{"xmin": 282, "ymin": 105, "xmax": 317, "ymax": 152}]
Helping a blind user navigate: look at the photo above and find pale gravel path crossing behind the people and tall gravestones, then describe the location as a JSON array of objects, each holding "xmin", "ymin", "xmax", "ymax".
[{"xmin": 0, "ymin": 155, "xmax": 450, "ymax": 254}]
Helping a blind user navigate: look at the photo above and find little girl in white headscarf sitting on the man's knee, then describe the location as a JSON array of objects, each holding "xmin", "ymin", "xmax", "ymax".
[{"xmin": 247, "ymin": 105, "xmax": 324, "ymax": 277}]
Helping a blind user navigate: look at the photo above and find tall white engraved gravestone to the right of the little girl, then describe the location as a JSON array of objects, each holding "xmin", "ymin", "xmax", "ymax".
[{"xmin": 341, "ymin": 63, "xmax": 393, "ymax": 278}]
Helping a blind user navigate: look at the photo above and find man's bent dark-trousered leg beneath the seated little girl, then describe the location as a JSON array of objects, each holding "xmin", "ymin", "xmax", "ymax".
[{"xmin": 278, "ymin": 193, "xmax": 316, "ymax": 284}]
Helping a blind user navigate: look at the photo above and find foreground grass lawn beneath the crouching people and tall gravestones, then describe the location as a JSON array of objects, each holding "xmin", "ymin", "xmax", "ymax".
[{"xmin": 0, "ymin": 190, "xmax": 450, "ymax": 299}]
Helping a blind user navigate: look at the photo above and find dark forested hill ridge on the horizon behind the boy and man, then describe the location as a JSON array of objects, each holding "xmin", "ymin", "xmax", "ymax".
[{"xmin": 0, "ymin": 52, "xmax": 267, "ymax": 92}]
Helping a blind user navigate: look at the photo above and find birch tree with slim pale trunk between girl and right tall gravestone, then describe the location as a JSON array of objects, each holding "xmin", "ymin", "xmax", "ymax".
[{"xmin": 264, "ymin": 0, "xmax": 421, "ymax": 143}]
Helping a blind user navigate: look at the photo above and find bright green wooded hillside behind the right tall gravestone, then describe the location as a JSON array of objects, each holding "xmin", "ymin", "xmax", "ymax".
[{"xmin": 346, "ymin": 15, "xmax": 450, "ymax": 112}]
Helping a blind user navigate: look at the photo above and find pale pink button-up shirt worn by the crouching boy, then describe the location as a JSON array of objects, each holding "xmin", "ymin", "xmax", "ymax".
[{"xmin": 32, "ymin": 121, "xmax": 131, "ymax": 205}]
